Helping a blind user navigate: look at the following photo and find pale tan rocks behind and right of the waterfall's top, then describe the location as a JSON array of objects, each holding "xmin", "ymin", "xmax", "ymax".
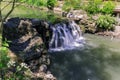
[{"xmin": 63, "ymin": 10, "xmax": 98, "ymax": 33}]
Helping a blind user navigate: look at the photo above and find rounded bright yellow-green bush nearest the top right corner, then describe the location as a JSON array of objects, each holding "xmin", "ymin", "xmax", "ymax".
[{"xmin": 101, "ymin": 1, "xmax": 115, "ymax": 14}]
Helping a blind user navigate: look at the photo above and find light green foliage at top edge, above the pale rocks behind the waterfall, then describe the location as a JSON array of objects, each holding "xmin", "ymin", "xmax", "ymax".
[{"xmin": 62, "ymin": 0, "xmax": 81, "ymax": 12}]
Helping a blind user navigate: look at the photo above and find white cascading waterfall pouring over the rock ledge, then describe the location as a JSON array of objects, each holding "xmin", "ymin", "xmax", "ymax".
[{"xmin": 49, "ymin": 21, "xmax": 85, "ymax": 51}]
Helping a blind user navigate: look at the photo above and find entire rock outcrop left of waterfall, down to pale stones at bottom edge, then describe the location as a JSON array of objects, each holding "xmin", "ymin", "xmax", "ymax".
[{"xmin": 3, "ymin": 18, "xmax": 55, "ymax": 80}]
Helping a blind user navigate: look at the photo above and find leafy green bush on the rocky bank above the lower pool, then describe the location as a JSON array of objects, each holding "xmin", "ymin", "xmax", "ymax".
[{"xmin": 96, "ymin": 15, "xmax": 116, "ymax": 30}]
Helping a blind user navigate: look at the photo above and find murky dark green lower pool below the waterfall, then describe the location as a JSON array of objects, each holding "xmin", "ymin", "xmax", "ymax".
[{"xmin": 50, "ymin": 34, "xmax": 120, "ymax": 80}]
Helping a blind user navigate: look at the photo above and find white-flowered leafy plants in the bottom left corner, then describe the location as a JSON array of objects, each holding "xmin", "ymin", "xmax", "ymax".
[{"xmin": 3, "ymin": 60, "xmax": 32, "ymax": 80}]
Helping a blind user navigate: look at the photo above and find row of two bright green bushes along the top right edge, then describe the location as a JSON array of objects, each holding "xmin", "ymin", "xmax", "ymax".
[{"xmin": 86, "ymin": 0, "xmax": 115, "ymax": 14}]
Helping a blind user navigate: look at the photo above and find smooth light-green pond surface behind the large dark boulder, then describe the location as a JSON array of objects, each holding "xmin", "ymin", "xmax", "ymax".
[{"xmin": 2, "ymin": 3, "xmax": 63, "ymax": 22}]
